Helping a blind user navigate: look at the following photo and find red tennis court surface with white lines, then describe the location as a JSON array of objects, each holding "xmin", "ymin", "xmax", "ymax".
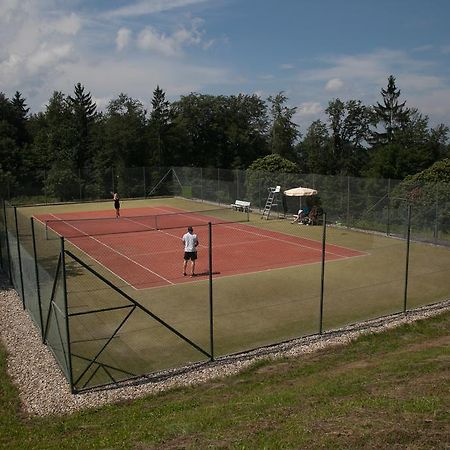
[{"xmin": 36, "ymin": 207, "xmax": 365, "ymax": 289}]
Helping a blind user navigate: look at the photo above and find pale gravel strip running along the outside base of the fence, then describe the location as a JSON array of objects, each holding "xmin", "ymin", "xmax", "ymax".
[{"xmin": 0, "ymin": 274, "xmax": 450, "ymax": 416}]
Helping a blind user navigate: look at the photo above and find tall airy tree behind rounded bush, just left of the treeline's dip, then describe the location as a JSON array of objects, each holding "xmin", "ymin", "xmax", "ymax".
[{"xmin": 268, "ymin": 92, "xmax": 300, "ymax": 160}]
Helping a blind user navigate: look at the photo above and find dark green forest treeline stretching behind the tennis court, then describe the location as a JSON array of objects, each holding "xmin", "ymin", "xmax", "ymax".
[{"xmin": 0, "ymin": 75, "xmax": 450, "ymax": 197}]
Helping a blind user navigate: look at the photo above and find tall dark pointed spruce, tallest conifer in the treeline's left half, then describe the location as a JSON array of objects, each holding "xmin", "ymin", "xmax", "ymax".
[{"xmin": 67, "ymin": 83, "xmax": 97, "ymax": 171}]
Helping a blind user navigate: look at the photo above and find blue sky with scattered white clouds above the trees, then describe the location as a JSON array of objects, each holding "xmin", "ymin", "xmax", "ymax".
[{"xmin": 0, "ymin": 0, "xmax": 450, "ymax": 131}]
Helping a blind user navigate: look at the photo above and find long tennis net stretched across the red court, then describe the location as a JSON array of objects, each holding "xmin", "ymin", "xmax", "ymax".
[{"xmin": 45, "ymin": 208, "xmax": 249, "ymax": 239}]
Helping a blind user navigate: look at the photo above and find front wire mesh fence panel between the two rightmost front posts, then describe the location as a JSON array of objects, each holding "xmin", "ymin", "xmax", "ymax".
[{"xmin": 324, "ymin": 201, "xmax": 407, "ymax": 329}]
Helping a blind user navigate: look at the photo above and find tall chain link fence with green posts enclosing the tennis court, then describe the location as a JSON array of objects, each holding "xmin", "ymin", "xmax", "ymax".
[{"xmin": 0, "ymin": 167, "xmax": 450, "ymax": 392}]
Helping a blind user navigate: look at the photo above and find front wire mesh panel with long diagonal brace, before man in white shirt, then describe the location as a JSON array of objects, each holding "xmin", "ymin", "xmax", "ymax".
[{"xmin": 62, "ymin": 221, "xmax": 214, "ymax": 389}]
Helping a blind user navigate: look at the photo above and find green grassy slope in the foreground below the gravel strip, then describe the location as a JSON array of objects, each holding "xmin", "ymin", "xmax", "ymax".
[{"xmin": 0, "ymin": 313, "xmax": 450, "ymax": 449}]
